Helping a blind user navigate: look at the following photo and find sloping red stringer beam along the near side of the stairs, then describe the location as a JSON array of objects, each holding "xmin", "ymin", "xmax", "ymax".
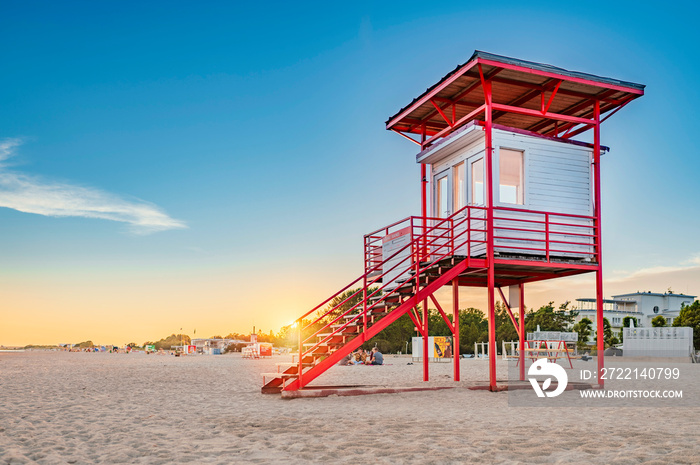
[{"xmin": 284, "ymin": 259, "xmax": 469, "ymax": 391}]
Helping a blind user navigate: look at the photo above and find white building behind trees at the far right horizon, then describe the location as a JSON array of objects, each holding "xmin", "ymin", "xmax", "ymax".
[{"xmin": 576, "ymin": 292, "xmax": 697, "ymax": 331}]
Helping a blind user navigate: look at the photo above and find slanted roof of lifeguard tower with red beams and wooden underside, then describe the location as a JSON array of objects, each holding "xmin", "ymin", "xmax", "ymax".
[{"xmin": 386, "ymin": 50, "xmax": 645, "ymax": 145}]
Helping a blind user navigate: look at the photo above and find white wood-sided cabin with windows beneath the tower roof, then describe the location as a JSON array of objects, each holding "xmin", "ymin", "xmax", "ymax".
[{"xmin": 417, "ymin": 124, "xmax": 595, "ymax": 261}]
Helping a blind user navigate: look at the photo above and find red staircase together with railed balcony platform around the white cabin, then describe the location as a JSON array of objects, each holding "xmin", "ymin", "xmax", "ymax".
[{"xmin": 262, "ymin": 206, "xmax": 599, "ymax": 393}]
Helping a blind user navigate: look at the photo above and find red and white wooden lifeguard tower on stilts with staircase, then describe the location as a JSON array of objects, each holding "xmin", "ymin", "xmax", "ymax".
[{"xmin": 262, "ymin": 51, "xmax": 644, "ymax": 392}]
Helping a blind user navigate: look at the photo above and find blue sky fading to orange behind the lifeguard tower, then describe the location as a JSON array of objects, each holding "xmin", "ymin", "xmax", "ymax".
[{"xmin": 0, "ymin": 2, "xmax": 700, "ymax": 344}]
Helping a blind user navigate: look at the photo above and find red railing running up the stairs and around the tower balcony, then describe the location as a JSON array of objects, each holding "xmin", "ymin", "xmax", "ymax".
[{"xmin": 297, "ymin": 206, "xmax": 599, "ymax": 386}]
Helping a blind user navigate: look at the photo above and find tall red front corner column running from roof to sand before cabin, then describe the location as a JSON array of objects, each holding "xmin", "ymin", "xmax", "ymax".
[{"xmin": 482, "ymin": 77, "xmax": 497, "ymax": 391}]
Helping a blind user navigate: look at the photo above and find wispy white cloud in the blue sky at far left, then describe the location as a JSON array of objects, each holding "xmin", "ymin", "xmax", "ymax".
[{"xmin": 0, "ymin": 138, "xmax": 187, "ymax": 234}]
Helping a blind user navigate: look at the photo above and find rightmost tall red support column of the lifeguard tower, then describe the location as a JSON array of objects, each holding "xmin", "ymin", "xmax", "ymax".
[{"xmin": 593, "ymin": 100, "xmax": 605, "ymax": 387}]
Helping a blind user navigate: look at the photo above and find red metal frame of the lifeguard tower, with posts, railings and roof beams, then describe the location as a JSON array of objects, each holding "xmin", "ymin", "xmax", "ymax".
[{"xmin": 264, "ymin": 55, "xmax": 644, "ymax": 396}]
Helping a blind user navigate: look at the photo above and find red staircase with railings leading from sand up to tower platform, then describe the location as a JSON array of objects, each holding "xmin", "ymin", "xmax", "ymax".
[{"xmin": 262, "ymin": 207, "xmax": 485, "ymax": 393}]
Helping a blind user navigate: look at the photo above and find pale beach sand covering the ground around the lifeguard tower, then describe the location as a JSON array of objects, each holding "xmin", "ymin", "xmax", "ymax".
[{"xmin": 0, "ymin": 352, "xmax": 700, "ymax": 464}]
